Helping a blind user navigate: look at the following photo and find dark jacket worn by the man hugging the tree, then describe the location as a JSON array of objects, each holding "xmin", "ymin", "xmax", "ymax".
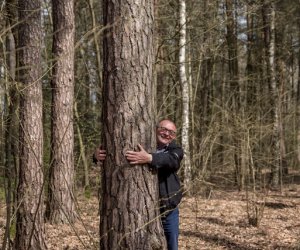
[{"xmin": 150, "ymin": 141, "xmax": 183, "ymax": 212}]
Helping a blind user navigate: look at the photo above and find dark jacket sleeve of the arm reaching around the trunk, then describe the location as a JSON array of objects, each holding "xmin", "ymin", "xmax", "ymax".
[{"xmin": 150, "ymin": 147, "xmax": 183, "ymax": 171}]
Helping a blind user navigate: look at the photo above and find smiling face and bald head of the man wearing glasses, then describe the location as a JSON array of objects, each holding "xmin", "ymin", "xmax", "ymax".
[{"xmin": 156, "ymin": 120, "xmax": 176, "ymax": 146}]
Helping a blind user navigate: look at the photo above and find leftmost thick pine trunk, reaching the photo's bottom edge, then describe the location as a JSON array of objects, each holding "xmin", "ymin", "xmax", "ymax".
[{"xmin": 15, "ymin": 0, "xmax": 46, "ymax": 249}]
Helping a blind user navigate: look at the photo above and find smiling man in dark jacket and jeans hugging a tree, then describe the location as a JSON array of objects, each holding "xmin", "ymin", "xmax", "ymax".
[{"xmin": 94, "ymin": 119, "xmax": 183, "ymax": 250}]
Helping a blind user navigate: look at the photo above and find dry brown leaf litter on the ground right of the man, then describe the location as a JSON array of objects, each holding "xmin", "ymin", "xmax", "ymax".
[{"xmin": 180, "ymin": 188, "xmax": 300, "ymax": 250}]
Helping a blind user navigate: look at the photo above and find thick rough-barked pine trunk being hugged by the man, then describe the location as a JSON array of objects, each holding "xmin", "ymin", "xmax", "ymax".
[{"xmin": 100, "ymin": 0, "xmax": 165, "ymax": 250}]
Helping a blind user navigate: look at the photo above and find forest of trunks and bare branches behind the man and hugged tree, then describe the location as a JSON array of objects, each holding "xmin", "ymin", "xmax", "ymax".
[{"xmin": 0, "ymin": 0, "xmax": 300, "ymax": 249}]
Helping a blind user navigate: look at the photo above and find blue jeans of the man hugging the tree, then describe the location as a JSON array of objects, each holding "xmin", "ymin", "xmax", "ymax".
[{"xmin": 161, "ymin": 207, "xmax": 179, "ymax": 250}]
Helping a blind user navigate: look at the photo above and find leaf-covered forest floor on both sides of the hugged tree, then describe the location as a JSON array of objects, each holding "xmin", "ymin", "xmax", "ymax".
[{"xmin": 0, "ymin": 178, "xmax": 300, "ymax": 250}]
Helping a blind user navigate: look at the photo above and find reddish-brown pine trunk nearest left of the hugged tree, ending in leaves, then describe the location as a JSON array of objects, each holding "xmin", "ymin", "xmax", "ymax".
[{"xmin": 47, "ymin": 0, "xmax": 76, "ymax": 223}]
